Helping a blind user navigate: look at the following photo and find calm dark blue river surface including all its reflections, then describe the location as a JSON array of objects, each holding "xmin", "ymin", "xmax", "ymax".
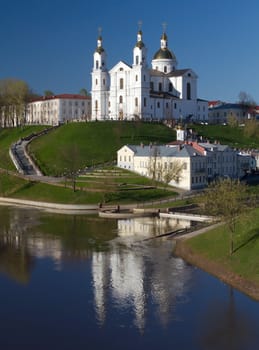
[{"xmin": 0, "ymin": 207, "xmax": 259, "ymax": 350}]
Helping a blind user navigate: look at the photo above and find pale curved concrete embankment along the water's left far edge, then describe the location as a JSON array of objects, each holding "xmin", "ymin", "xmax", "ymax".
[{"xmin": 0, "ymin": 197, "xmax": 99, "ymax": 214}]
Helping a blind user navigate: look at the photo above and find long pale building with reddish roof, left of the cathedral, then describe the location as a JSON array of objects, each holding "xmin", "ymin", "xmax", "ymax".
[{"xmin": 26, "ymin": 94, "xmax": 91, "ymax": 125}]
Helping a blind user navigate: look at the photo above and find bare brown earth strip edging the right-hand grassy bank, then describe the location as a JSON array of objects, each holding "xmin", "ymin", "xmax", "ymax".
[{"xmin": 174, "ymin": 224, "xmax": 259, "ymax": 301}]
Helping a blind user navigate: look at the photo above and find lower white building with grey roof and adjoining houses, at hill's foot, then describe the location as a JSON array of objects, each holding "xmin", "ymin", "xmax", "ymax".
[{"xmin": 117, "ymin": 142, "xmax": 254, "ymax": 190}]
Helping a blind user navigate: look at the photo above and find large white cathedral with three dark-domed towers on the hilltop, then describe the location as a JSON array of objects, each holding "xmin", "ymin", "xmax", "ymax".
[{"xmin": 91, "ymin": 30, "xmax": 208, "ymax": 122}]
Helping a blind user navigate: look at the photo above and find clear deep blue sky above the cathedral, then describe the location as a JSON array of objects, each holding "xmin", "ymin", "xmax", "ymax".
[{"xmin": 0, "ymin": 0, "xmax": 259, "ymax": 103}]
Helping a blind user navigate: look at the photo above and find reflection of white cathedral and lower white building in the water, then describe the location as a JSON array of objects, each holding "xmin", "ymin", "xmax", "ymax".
[{"xmin": 92, "ymin": 218, "xmax": 190, "ymax": 330}]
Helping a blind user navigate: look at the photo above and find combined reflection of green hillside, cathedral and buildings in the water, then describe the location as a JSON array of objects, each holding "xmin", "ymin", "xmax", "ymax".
[{"xmin": 0, "ymin": 208, "xmax": 193, "ymax": 329}]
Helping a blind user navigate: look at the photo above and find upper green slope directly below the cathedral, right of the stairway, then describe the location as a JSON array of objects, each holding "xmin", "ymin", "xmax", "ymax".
[{"xmin": 29, "ymin": 121, "xmax": 175, "ymax": 175}]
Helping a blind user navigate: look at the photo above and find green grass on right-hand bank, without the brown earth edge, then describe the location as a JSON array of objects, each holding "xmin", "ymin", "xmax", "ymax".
[{"xmin": 185, "ymin": 208, "xmax": 259, "ymax": 283}]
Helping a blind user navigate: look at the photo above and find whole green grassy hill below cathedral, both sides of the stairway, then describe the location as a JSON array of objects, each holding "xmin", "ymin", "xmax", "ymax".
[{"xmin": 0, "ymin": 122, "xmax": 180, "ymax": 204}]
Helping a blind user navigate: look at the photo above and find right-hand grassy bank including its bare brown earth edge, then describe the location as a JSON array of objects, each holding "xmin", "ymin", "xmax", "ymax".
[{"xmin": 176, "ymin": 208, "xmax": 259, "ymax": 299}]
